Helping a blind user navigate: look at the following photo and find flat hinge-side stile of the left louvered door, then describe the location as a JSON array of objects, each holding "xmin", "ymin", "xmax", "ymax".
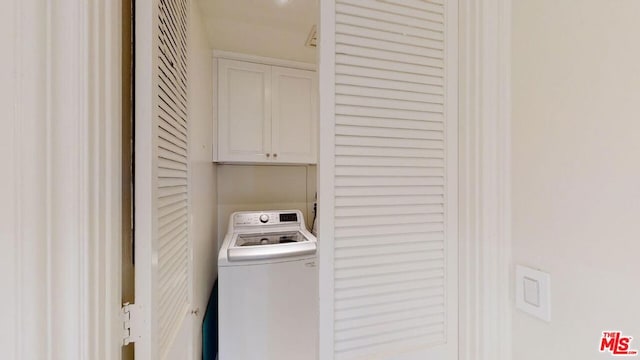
[{"xmin": 134, "ymin": 0, "xmax": 160, "ymax": 360}]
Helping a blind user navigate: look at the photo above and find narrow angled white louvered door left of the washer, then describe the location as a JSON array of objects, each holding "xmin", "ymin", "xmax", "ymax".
[{"xmin": 132, "ymin": 0, "xmax": 193, "ymax": 360}]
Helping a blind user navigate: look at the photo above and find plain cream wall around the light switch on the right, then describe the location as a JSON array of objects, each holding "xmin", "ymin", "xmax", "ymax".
[{"xmin": 512, "ymin": 0, "xmax": 640, "ymax": 360}]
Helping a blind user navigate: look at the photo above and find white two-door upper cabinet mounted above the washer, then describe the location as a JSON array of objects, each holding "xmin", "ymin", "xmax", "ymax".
[{"xmin": 217, "ymin": 59, "xmax": 317, "ymax": 164}]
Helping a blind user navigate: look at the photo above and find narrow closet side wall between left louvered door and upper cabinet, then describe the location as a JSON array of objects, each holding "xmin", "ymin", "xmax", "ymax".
[{"xmin": 188, "ymin": 1, "xmax": 218, "ymax": 359}]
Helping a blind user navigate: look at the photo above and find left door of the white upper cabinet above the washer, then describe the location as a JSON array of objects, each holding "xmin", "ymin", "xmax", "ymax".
[{"xmin": 218, "ymin": 59, "xmax": 271, "ymax": 162}]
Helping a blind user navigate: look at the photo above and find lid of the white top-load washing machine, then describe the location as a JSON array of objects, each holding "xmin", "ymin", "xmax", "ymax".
[{"xmin": 227, "ymin": 231, "xmax": 316, "ymax": 261}]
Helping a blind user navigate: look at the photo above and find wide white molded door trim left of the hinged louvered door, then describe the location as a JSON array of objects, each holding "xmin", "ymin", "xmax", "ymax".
[{"xmin": 8, "ymin": 0, "xmax": 121, "ymax": 360}]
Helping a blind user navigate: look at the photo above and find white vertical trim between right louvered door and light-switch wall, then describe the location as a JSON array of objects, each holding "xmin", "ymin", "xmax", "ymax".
[{"xmin": 460, "ymin": 0, "xmax": 511, "ymax": 360}]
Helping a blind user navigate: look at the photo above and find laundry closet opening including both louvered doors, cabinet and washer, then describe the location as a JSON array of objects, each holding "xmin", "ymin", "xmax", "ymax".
[{"xmin": 123, "ymin": 0, "xmax": 458, "ymax": 360}]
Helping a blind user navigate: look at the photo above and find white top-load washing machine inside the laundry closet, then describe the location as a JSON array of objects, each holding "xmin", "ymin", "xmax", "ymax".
[{"xmin": 218, "ymin": 210, "xmax": 318, "ymax": 360}]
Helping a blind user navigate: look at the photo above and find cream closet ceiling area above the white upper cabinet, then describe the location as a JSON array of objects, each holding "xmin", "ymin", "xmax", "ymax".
[{"xmin": 198, "ymin": 0, "xmax": 318, "ymax": 62}]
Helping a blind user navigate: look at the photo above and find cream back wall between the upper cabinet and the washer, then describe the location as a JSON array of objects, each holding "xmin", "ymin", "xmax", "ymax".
[{"xmin": 218, "ymin": 165, "xmax": 316, "ymax": 245}]
